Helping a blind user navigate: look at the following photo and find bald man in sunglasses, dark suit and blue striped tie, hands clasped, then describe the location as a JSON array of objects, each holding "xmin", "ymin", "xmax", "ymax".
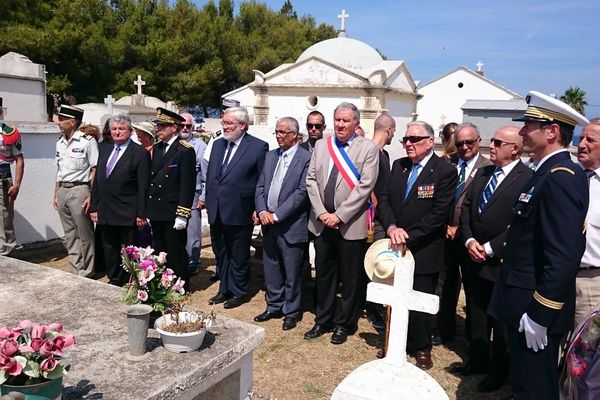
[{"xmin": 460, "ymin": 126, "xmax": 533, "ymax": 392}]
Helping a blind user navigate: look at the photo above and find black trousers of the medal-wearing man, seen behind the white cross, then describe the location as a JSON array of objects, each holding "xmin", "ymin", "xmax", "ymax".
[{"xmin": 408, "ymin": 273, "xmax": 439, "ymax": 355}]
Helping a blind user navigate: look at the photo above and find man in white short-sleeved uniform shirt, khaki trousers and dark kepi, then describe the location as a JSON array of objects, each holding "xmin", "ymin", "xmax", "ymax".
[{"xmin": 54, "ymin": 105, "xmax": 98, "ymax": 277}]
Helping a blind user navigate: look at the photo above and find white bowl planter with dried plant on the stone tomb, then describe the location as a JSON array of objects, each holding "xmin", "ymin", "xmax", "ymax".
[{"xmin": 154, "ymin": 297, "xmax": 216, "ymax": 353}]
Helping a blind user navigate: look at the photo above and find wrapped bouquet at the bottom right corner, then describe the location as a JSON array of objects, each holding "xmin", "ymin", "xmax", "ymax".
[{"xmin": 561, "ymin": 310, "xmax": 600, "ymax": 400}]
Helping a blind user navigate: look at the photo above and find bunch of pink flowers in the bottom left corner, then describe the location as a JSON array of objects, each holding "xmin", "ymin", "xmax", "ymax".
[{"xmin": 0, "ymin": 320, "xmax": 75, "ymax": 386}]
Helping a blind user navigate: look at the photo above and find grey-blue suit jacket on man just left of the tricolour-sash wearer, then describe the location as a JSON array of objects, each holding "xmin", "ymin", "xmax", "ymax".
[{"xmin": 255, "ymin": 146, "xmax": 310, "ymax": 244}]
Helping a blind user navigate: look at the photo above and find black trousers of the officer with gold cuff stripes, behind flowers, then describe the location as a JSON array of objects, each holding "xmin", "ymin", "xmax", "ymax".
[{"xmin": 150, "ymin": 222, "xmax": 190, "ymax": 292}]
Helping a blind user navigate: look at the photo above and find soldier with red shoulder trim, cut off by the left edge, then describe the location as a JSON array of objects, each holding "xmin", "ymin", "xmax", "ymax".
[{"xmin": 0, "ymin": 98, "xmax": 25, "ymax": 255}]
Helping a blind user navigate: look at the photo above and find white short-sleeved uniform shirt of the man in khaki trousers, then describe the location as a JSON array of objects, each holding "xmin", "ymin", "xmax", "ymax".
[{"xmin": 56, "ymin": 131, "xmax": 98, "ymax": 182}]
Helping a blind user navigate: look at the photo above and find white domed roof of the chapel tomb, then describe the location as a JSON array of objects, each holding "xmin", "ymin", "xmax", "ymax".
[{"xmin": 296, "ymin": 37, "xmax": 383, "ymax": 69}]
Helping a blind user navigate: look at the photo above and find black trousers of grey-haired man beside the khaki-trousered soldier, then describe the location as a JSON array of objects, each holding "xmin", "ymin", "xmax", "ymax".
[{"xmin": 96, "ymin": 224, "xmax": 137, "ymax": 286}]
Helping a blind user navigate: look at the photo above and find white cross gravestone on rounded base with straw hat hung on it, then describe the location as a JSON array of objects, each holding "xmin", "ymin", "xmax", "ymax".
[{"xmin": 331, "ymin": 239, "xmax": 448, "ymax": 400}]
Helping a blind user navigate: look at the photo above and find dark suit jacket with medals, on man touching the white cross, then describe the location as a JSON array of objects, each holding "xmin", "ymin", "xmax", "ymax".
[{"xmin": 377, "ymin": 153, "xmax": 458, "ymax": 274}]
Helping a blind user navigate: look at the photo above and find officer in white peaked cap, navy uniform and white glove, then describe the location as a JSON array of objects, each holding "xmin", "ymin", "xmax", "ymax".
[{"xmin": 488, "ymin": 91, "xmax": 588, "ymax": 400}]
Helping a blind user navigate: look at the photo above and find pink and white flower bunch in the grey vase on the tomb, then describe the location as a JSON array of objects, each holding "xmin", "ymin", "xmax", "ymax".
[{"xmin": 121, "ymin": 246, "xmax": 185, "ymax": 314}]
